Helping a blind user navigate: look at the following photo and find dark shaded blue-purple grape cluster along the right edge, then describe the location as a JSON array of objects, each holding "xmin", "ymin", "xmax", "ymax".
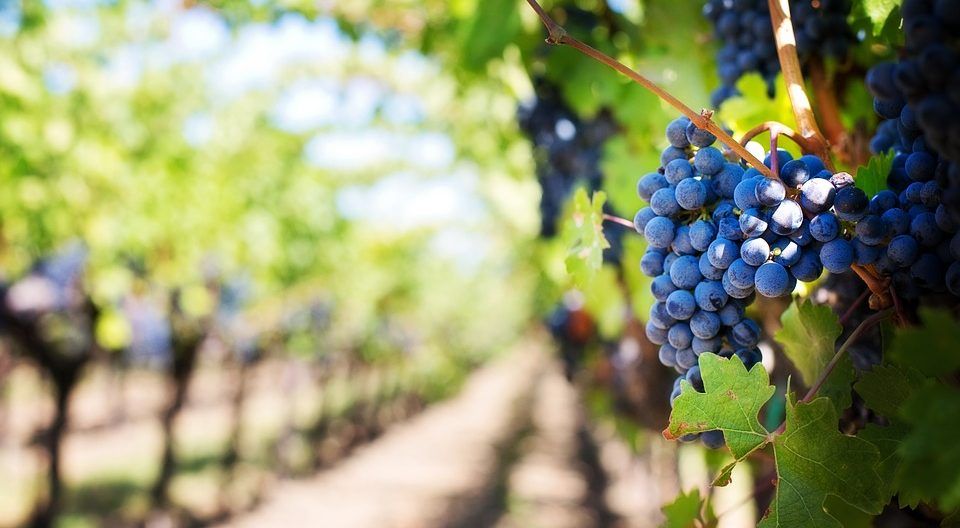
[{"xmin": 854, "ymin": 0, "xmax": 960, "ymax": 298}]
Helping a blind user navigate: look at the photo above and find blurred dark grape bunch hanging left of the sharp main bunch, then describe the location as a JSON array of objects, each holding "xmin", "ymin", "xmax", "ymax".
[{"xmin": 517, "ymin": 78, "xmax": 628, "ymax": 262}]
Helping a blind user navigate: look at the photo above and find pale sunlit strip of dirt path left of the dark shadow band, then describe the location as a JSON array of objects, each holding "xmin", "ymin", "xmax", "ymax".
[{"xmin": 220, "ymin": 345, "xmax": 546, "ymax": 528}]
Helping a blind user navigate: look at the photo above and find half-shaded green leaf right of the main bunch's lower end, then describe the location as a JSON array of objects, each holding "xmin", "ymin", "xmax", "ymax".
[{"xmin": 774, "ymin": 299, "xmax": 843, "ymax": 387}]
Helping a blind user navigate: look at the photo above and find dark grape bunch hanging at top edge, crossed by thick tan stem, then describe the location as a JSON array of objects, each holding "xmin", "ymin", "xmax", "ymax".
[{"xmin": 703, "ymin": 0, "xmax": 854, "ymax": 108}]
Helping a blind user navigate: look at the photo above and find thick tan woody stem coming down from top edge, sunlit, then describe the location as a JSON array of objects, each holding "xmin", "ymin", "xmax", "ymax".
[{"xmin": 769, "ymin": 0, "xmax": 835, "ymax": 172}]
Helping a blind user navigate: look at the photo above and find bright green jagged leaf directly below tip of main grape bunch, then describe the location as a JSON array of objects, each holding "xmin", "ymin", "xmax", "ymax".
[{"xmin": 663, "ymin": 354, "xmax": 776, "ymax": 459}]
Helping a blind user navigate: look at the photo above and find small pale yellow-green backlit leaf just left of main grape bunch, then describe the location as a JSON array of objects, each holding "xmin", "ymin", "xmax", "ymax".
[{"xmin": 566, "ymin": 187, "xmax": 610, "ymax": 286}]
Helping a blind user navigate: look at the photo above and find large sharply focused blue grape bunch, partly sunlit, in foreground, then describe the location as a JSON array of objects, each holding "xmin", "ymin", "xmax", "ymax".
[{"xmin": 634, "ymin": 117, "xmax": 896, "ymax": 445}]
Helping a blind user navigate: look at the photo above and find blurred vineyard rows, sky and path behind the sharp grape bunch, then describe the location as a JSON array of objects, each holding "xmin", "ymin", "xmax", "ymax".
[{"xmin": 0, "ymin": 0, "xmax": 942, "ymax": 527}]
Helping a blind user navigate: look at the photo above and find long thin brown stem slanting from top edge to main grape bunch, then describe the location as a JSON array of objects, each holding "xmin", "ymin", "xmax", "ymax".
[{"xmin": 527, "ymin": 0, "xmax": 776, "ymax": 179}]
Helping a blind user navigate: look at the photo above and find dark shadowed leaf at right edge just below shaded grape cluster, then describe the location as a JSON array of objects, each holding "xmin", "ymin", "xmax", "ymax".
[{"xmin": 888, "ymin": 308, "xmax": 960, "ymax": 377}]
